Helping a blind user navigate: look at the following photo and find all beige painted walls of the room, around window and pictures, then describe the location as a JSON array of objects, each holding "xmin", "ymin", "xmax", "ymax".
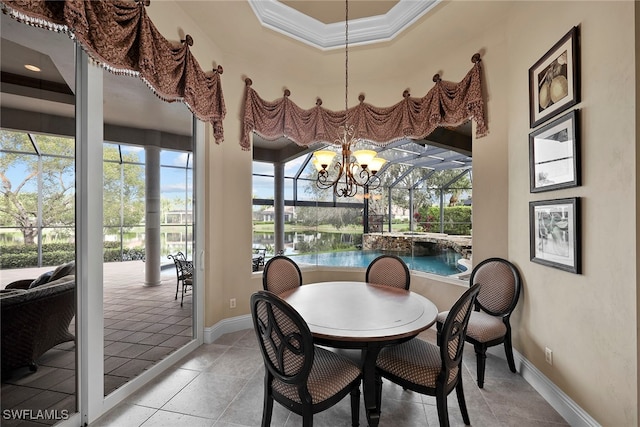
[{"xmin": 148, "ymin": 1, "xmax": 638, "ymax": 426}]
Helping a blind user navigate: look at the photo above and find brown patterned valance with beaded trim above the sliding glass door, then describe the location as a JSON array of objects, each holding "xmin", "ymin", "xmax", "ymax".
[{"xmin": 0, "ymin": 0, "xmax": 226, "ymax": 143}]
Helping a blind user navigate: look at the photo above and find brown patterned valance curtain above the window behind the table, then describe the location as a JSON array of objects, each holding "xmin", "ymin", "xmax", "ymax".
[{"xmin": 240, "ymin": 54, "xmax": 488, "ymax": 150}]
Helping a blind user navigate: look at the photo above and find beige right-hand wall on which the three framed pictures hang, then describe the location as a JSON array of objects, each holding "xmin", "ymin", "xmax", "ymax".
[{"xmin": 508, "ymin": 2, "xmax": 638, "ymax": 426}]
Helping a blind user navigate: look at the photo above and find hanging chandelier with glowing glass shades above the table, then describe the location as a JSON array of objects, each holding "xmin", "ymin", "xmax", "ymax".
[{"xmin": 312, "ymin": 0, "xmax": 386, "ymax": 197}]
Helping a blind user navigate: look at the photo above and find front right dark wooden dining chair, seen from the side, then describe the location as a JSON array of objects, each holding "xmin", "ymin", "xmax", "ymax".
[{"xmin": 376, "ymin": 285, "xmax": 480, "ymax": 427}]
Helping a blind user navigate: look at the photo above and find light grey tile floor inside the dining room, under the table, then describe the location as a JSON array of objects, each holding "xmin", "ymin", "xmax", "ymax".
[{"xmin": 91, "ymin": 329, "xmax": 568, "ymax": 427}]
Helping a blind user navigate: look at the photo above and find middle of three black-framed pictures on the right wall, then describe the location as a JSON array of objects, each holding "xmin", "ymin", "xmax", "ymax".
[{"xmin": 529, "ymin": 110, "xmax": 580, "ymax": 193}]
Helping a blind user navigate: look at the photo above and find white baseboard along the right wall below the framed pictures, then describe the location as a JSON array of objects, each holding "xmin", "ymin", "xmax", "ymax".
[{"xmin": 487, "ymin": 346, "xmax": 601, "ymax": 427}]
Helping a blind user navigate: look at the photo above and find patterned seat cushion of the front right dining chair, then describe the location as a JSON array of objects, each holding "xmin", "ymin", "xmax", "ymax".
[{"xmin": 376, "ymin": 338, "xmax": 458, "ymax": 388}]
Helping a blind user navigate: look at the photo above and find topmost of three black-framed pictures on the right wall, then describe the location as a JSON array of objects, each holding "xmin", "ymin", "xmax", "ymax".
[{"xmin": 529, "ymin": 27, "xmax": 580, "ymax": 128}]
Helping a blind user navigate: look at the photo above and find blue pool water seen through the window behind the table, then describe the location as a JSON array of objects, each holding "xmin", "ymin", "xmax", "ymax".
[{"xmin": 287, "ymin": 250, "xmax": 462, "ymax": 276}]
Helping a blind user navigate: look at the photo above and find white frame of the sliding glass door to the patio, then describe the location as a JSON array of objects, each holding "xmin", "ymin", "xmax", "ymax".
[{"xmin": 70, "ymin": 45, "xmax": 205, "ymax": 426}]
